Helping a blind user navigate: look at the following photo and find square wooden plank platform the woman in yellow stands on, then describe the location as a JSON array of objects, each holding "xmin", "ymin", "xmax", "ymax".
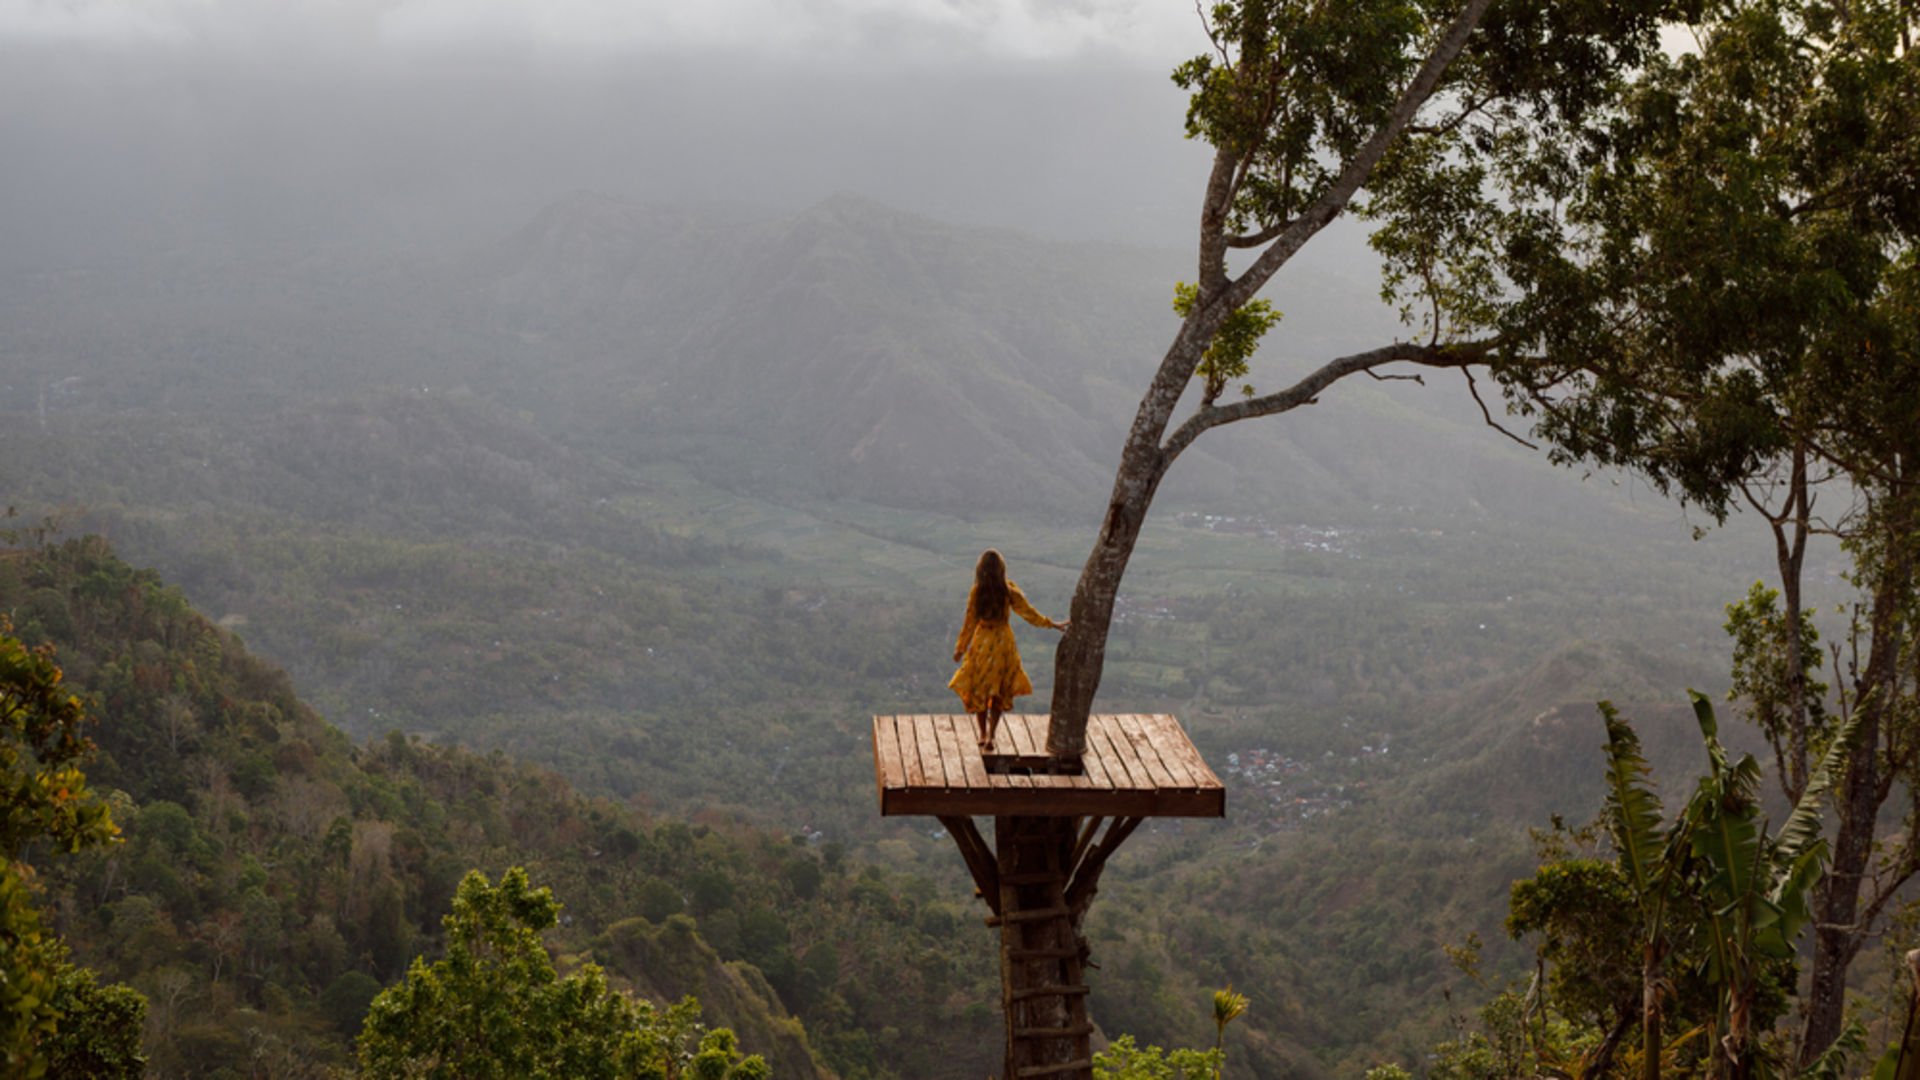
[{"xmin": 874, "ymin": 713, "xmax": 1227, "ymax": 817}]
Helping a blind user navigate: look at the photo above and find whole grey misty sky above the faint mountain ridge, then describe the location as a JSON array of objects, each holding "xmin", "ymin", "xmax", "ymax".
[{"xmin": 0, "ymin": 0, "xmax": 1320, "ymax": 265}]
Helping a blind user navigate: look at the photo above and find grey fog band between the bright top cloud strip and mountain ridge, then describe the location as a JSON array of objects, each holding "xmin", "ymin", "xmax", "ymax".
[{"xmin": 0, "ymin": 44, "xmax": 1206, "ymax": 265}]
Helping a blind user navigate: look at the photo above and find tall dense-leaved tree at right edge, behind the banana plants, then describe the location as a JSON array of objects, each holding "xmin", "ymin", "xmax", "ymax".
[{"xmin": 1451, "ymin": 0, "xmax": 1920, "ymax": 1067}]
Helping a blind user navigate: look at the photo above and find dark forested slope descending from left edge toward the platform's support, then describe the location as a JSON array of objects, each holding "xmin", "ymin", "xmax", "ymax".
[{"xmin": 0, "ymin": 540, "xmax": 1021, "ymax": 1076}]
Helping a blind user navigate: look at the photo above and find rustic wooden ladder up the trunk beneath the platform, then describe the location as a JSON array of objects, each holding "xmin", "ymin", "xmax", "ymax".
[{"xmin": 995, "ymin": 817, "xmax": 1092, "ymax": 1080}]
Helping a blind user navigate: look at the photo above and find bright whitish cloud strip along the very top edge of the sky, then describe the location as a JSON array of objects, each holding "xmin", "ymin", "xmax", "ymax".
[{"xmin": 0, "ymin": 0, "xmax": 1196, "ymax": 67}]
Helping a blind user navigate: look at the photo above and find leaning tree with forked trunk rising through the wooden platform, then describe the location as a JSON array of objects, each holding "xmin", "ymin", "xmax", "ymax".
[{"xmin": 1048, "ymin": 0, "xmax": 1686, "ymax": 759}]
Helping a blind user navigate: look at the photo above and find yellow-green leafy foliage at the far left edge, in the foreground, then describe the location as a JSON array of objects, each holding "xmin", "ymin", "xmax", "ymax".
[{"xmin": 0, "ymin": 615, "xmax": 146, "ymax": 1076}]
